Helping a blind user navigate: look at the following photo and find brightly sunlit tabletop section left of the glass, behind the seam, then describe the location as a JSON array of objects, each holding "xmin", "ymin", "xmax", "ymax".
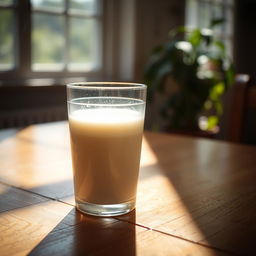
[{"xmin": 0, "ymin": 122, "xmax": 73, "ymax": 199}]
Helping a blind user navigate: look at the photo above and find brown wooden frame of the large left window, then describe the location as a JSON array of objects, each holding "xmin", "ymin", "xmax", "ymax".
[{"xmin": 0, "ymin": 0, "xmax": 109, "ymax": 86}]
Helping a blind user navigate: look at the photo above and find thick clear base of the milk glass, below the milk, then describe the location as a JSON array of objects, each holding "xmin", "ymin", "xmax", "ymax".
[{"xmin": 76, "ymin": 200, "xmax": 135, "ymax": 217}]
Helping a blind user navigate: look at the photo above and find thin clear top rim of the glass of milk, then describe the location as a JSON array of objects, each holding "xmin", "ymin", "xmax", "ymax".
[{"xmin": 67, "ymin": 82, "xmax": 147, "ymax": 90}]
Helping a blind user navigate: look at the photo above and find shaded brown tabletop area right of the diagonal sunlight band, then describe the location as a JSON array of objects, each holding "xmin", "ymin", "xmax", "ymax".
[{"xmin": 145, "ymin": 134, "xmax": 256, "ymax": 255}]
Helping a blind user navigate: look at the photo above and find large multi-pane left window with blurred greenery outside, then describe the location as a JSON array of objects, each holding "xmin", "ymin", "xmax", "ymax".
[{"xmin": 0, "ymin": 0, "xmax": 103, "ymax": 83}]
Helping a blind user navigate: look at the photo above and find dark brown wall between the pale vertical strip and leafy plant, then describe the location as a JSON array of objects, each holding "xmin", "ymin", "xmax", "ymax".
[{"xmin": 134, "ymin": 0, "xmax": 185, "ymax": 81}]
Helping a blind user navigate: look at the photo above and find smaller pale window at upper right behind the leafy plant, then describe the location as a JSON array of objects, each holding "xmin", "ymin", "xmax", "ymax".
[{"xmin": 186, "ymin": 0, "xmax": 234, "ymax": 57}]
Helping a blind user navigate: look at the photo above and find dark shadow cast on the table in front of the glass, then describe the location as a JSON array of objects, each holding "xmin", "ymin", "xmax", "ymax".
[{"xmin": 29, "ymin": 208, "xmax": 136, "ymax": 256}]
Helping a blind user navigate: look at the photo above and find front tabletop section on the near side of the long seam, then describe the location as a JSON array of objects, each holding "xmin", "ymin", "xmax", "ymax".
[{"xmin": 0, "ymin": 198, "xmax": 226, "ymax": 256}]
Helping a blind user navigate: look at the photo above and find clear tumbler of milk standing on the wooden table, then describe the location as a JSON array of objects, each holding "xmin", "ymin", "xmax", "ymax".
[{"xmin": 67, "ymin": 82, "xmax": 147, "ymax": 216}]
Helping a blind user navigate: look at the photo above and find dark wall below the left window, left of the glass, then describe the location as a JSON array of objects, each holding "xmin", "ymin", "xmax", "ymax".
[{"xmin": 0, "ymin": 85, "xmax": 67, "ymax": 129}]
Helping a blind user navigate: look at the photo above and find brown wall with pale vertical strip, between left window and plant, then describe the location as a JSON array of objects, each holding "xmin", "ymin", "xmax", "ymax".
[{"xmin": 111, "ymin": 0, "xmax": 185, "ymax": 82}]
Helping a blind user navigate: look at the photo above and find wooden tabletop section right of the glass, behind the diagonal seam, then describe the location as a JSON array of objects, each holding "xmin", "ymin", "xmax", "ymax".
[{"xmin": 134, "ymin": 134, "xmax": 256, "ymax": 255}]
